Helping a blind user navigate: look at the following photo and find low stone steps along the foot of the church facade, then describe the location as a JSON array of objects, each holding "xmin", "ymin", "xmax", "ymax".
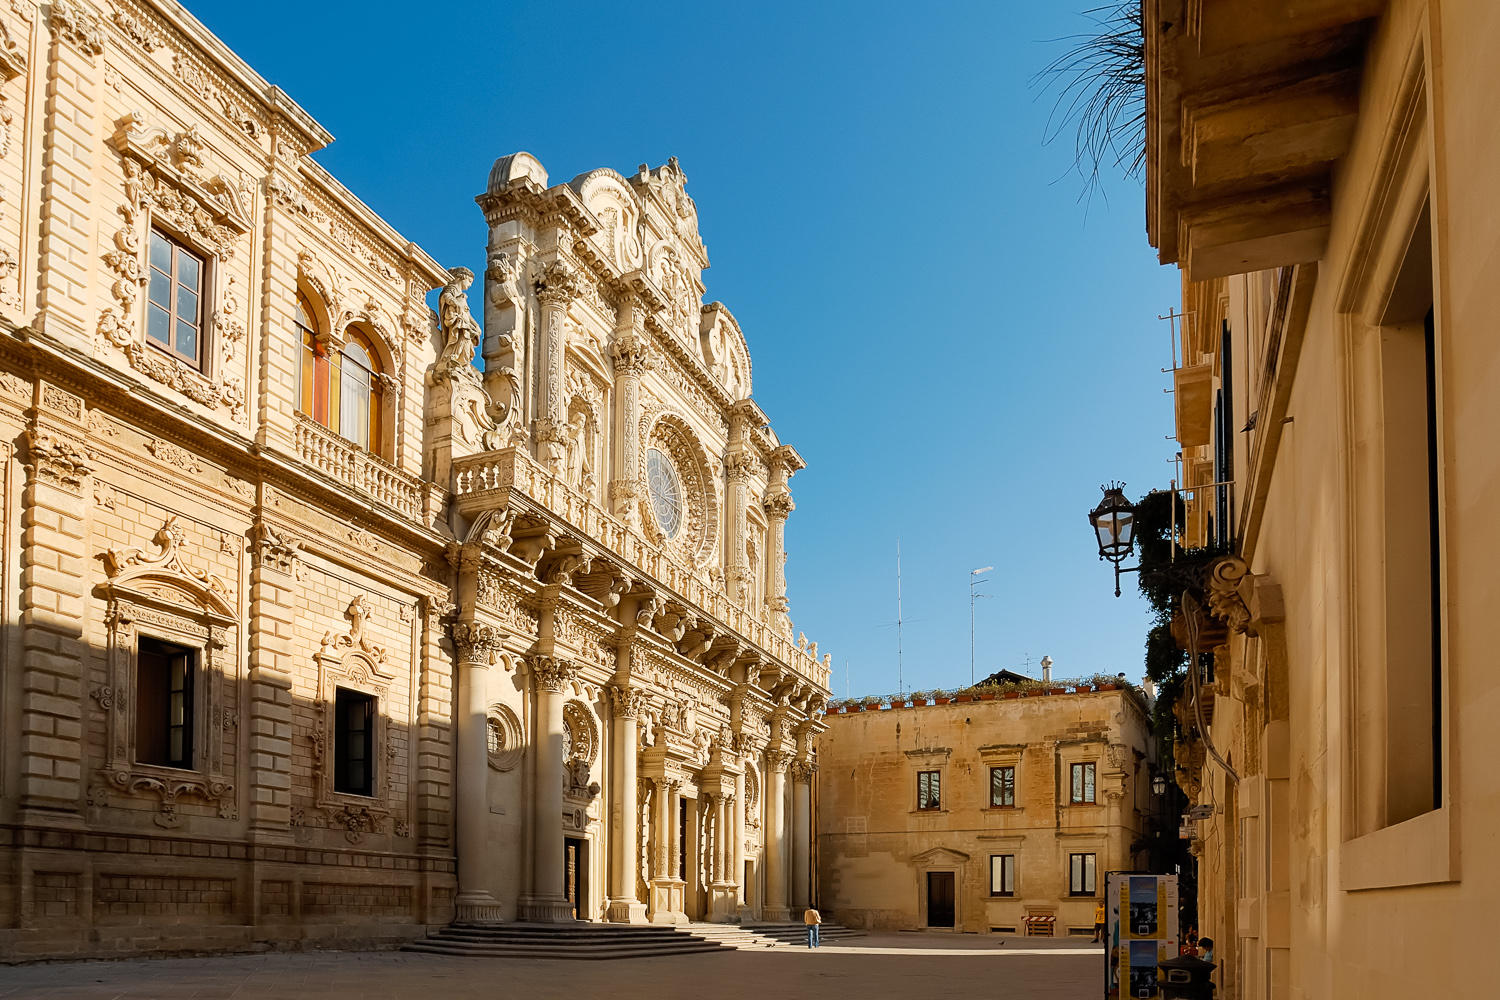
[{"xmin": 402, "ymin": 922, "xmax": 861, "ymax": 961}]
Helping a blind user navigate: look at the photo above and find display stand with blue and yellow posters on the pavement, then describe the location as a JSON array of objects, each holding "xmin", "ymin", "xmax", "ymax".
[{"xmin": 1104, "ymin": 871, "xmax": 1178, "ymax": 1000}]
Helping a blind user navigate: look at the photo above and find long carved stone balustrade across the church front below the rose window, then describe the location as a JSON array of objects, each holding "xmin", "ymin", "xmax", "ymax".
[{"xmin": 453, "ymin": 448, "xmax": 830, "ymax": 690}]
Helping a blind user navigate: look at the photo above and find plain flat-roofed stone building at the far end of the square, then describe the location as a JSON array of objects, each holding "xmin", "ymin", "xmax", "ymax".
[{"xmin": 818, "ymin": 687, "xmax": 1154, "ymax": 936}]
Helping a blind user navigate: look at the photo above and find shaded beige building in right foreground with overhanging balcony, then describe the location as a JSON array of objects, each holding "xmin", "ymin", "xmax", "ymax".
[{"xmin": 1145, "ymin": 0, "xmax": 1500, "ymax": 1000}]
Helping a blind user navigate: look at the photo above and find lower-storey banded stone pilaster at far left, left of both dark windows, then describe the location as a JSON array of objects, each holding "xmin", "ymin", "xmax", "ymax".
[{"xmin": 17, "ymin": 419, "xmax": 91, "ymax": 826}]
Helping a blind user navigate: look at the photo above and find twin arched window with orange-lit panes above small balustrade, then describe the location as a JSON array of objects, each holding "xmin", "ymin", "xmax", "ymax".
[{"xmin": 297, "ymin": 292, "xmax": 383, "ymax": 453}]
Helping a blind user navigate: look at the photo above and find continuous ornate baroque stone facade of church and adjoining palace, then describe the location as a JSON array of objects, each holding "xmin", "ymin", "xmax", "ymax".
[{"xmin": 0, "ymin": 0, "xmax": 830, "ymax": 958}]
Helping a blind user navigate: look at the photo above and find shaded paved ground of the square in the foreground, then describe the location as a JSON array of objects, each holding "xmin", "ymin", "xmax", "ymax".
[{"xmin": 0, "ymin": 934, "xmax": 1103, "ymax": 1000}]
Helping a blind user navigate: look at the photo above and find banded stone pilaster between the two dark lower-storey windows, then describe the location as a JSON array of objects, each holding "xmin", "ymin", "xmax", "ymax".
[{"xmin": 248, "ymin": 520, "xmax": 302, "ymax": 832}]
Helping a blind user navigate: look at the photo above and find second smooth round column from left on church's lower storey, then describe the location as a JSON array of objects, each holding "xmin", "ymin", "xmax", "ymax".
[{"xmin": 521, "ymin": 654, "xmax": 578, "ymax": 924}]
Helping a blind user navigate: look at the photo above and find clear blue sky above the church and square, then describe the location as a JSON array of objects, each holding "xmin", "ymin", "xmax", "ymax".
[{"xmin": 199, "ymin": 0, "xmax": 1178, "ymax": 696}]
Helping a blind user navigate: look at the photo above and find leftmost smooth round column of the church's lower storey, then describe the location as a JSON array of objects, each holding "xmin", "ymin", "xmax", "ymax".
[{"xmin": 453, "ymin": 622, "xmax": 501, "ymax": 922}]
